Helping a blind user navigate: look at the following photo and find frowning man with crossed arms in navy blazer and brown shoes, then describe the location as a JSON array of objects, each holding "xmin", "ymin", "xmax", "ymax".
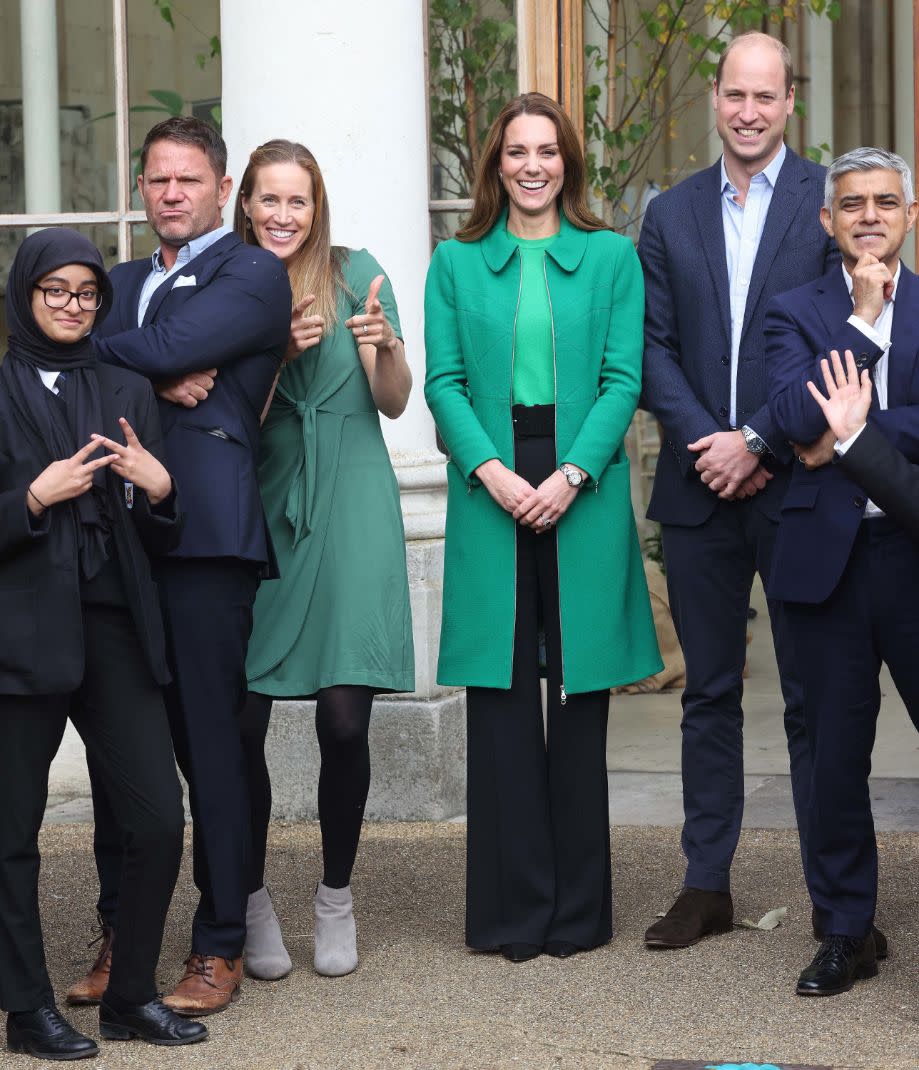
[{"xmin": 68, "ymin": 118, "xmax": 291, "ymax": 1014}]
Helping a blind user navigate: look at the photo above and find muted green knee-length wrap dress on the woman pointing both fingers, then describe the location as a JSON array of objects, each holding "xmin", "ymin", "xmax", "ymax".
[{"xmin": 246, "ymin": 249, "xmax": 415, "ymax": 699}]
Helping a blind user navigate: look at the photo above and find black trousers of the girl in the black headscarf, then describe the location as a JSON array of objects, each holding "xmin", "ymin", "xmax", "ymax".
[{"xmin": 0, "ymin": 606, "xmax": 185, "ymax": 1011}]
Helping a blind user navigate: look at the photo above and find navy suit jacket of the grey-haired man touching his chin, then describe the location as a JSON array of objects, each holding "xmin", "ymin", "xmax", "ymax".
[{"xmin": 766, "ymin": 264, "xmax": 919, "ymax": 603}]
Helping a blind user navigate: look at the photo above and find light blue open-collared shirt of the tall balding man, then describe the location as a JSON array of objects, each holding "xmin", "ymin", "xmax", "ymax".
[{"xmin": 721, "ymin": 144, "xmax": 787, "ymax": 430}]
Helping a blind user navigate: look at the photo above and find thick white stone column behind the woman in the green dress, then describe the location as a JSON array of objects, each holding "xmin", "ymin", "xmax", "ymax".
[{"xmin": 220, "ymin": 0, "xmax": 465, "ymax": 819}]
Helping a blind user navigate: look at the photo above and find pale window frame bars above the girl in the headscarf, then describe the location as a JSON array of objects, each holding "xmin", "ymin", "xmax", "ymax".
[{"xmin": 0, "ymin": 0, "xmax": 147, "ymax": 261}]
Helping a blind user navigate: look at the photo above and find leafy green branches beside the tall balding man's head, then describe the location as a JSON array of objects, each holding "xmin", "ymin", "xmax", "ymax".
[{"xmin": 584, "ymin": 0, "xmax": 840, "ymax": 220}]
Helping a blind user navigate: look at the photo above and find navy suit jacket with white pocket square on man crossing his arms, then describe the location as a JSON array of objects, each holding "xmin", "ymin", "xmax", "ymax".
[{"xmin": 95, "ymin": 234, "xmax": 291, "ymax": 576}]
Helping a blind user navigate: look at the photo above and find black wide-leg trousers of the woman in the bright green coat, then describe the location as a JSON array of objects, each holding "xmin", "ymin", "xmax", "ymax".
[{"xmin": 465, "ymin": 437, "xmax": 613, "ymax": 950}]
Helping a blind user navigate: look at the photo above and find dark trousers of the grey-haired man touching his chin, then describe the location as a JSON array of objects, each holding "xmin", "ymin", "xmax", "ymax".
[{"xmin": 786, "ymin": 518, "xmax": 919, "ymax": 936}]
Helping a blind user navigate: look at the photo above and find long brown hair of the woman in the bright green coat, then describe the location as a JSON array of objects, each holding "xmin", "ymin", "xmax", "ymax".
[{"xmin": 456, "ymin": 93, "xmax": 611, "ymax": 242}]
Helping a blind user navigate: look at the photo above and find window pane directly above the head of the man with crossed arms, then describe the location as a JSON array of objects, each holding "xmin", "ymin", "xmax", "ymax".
[{"xmin": 127, "ymin": 0, "xmax": 220, "ymax": 210}]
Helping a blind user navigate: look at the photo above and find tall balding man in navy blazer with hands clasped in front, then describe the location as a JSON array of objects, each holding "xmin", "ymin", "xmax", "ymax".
[{"xmin": 639, "ymin": 33, "xmax": 838, "ymax": 948}]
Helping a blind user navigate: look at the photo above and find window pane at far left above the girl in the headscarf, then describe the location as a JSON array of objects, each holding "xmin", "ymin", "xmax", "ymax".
[{"xmin": 0, "ymin": 0, "xmax": 116, "ymax": 213}]
